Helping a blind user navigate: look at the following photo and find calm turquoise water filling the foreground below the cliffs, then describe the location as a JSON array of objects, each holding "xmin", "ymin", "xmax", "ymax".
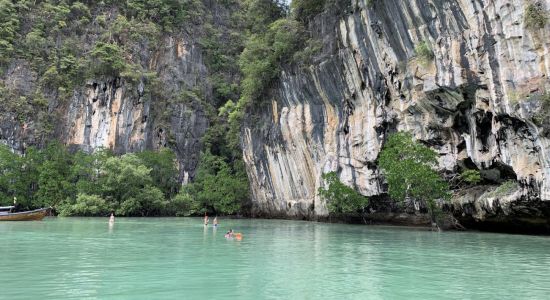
[{"xmin": 0, "ymin": 218, "xmax": 550, "ymax": 299}]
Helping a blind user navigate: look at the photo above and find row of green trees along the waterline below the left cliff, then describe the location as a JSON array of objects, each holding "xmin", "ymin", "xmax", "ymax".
[{"xmin": 0, "ymin": 142, "xmax": 248, "ymax": 216}]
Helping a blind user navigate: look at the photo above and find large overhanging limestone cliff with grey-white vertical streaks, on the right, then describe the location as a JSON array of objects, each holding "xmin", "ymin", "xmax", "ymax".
[{"xmin": 242, "ymin": 0, "xmax": 550, "ymax": 230}]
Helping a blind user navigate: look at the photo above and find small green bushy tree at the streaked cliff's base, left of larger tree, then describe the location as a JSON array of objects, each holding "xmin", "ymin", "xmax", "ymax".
[{"xmin": 318, "ymin": 172, "xmax": 369, "ymax": 214}]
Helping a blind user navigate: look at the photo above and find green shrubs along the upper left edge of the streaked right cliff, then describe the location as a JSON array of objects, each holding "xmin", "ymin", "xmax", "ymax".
[{"xmin": 222, "ymin": 0, "xmax": 327, "ymax": 152}]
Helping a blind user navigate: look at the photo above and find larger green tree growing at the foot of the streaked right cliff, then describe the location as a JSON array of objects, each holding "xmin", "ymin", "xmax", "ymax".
[{"xmin": 378, "ymin": 132, "xmax": 450, "ymax": 221}]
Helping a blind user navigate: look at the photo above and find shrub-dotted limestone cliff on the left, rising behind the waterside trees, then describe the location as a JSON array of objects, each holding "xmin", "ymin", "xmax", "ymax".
[{"xmin": 0, "ymin": 2, "xmax": 221, "ymax": 181}]
